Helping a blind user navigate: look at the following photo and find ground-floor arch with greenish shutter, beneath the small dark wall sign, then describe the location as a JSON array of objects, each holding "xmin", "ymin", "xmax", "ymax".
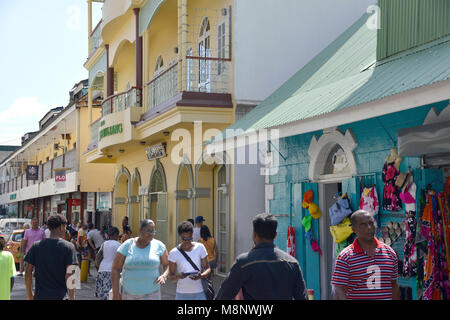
[{"xmin": 148, "ymin": 159, "xmax": 169, "ymax": 245}]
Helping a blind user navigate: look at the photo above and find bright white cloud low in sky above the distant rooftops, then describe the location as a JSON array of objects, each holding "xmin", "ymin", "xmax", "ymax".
[{"xmin": 0, "ymin": 97, "xmax": 51, "ymax": 145}]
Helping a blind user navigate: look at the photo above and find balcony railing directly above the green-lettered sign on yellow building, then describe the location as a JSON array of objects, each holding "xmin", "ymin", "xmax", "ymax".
[{"xmin": 102, "ymin": 87, "xmax": 142, "ymax": 117}]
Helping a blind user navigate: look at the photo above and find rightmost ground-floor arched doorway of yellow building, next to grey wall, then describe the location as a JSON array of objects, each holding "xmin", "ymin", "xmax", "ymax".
[{"xmin": 194, "ymin": 153, "xmax": 232, "ymax": 275}]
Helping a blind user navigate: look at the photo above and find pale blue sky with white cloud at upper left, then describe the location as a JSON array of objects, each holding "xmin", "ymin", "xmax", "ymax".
[{"xmin": 0, "ymin": 0, "xmax": 101, "ymax": 145}]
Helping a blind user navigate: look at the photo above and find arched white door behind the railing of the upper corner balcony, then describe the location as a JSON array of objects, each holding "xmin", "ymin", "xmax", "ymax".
[{"xmin": 198, "ymin": 17, "xmax": 211, "ymax": 92}]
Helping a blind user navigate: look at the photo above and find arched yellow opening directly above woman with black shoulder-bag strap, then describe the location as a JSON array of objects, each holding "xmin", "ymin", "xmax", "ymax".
[{"xmin": 175, "ymin": 157, "xmax": 194, "ymax": 243}]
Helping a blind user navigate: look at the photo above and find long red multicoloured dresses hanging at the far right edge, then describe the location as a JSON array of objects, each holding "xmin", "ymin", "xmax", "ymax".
[{"xmin": 420, "ymin": 190, "xmax": 450, "ymax": 300}]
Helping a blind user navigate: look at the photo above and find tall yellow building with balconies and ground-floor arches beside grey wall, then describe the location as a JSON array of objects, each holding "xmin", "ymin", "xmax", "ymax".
[{"xmin": 85, "ymin": 0, "xmax": 234, "ymax": 273}]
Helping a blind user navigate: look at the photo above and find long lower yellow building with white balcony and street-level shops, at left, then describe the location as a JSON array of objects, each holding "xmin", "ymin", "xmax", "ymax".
[{"xmin": 0, "ymin": 80, "xmax": 114, "ymax": 227}]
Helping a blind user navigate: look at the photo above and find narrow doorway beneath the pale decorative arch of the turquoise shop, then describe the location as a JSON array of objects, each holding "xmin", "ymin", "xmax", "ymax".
[{"xmin": 319, "ymin": 182, "xmax": 342, "ymax": 300}]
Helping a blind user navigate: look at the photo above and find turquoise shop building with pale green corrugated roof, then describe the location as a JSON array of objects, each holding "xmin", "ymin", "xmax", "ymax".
[{"xmin": 216, "ymin": 0, "xmax": 450, "ymax": 300}]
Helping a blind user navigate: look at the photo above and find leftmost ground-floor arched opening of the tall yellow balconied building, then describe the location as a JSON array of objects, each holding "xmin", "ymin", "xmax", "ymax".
[{"xmin": 113, "ymin": 166, "xmax": 130, "ymax": 232}]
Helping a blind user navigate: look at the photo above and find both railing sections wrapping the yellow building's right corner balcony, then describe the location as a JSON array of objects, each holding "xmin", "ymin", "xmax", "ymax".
[{"xmin": 144, "ymin": 56, "xmax": 231, "ymax": 112}]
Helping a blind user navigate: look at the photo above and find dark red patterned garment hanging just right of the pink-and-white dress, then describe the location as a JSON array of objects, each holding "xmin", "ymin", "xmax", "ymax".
[{"xmin": 382, "ymin": 162, "xmax": 402, "ymax": 211}]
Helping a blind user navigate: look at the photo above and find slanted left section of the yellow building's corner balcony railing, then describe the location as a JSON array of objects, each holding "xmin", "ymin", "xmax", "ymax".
[{"xmin": 145, "ymin": 63, "xmax": 178, "ymax": 112}]
